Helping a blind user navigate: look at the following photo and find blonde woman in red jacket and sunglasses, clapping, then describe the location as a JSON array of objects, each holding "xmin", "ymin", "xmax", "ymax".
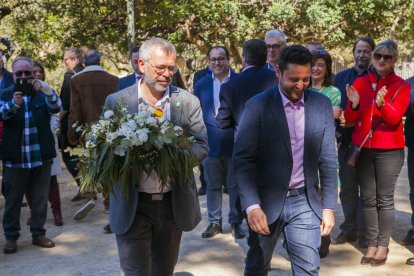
[{"xmin": 345, "ymin": 40, "xmax": 410, "ymax": 266}]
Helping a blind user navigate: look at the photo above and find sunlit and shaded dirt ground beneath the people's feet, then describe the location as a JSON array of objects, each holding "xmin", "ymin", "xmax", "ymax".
[{"xmin": 0, "ymin": 157, "xmax": 414, "ymax": 276}]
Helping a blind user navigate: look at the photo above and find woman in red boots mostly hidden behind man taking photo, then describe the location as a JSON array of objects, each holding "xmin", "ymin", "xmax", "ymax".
[{"xmin": 25, "ymin": 61, "xmax": 63, "ymax": 226}]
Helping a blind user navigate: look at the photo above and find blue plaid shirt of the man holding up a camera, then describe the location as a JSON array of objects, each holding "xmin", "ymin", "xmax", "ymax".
[{"xmin": 0, "ymin": 92, "xmax": 61, "ymax": 169}]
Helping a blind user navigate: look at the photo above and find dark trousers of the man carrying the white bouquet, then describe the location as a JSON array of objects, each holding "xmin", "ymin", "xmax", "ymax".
[{"xmin": 116, "ymin": 192, "xmax": 182, "ymax": 276}]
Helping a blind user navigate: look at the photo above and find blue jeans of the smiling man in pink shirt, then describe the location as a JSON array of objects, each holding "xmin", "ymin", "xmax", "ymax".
[{"xmin": 244, "ymin": 194, "xmax": 321, "ymax": 276}]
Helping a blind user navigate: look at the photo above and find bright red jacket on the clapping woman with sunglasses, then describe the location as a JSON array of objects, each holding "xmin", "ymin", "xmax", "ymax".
[{"xmin": 345, "ymin": 71, "xmax": 410, "ymax": 149}]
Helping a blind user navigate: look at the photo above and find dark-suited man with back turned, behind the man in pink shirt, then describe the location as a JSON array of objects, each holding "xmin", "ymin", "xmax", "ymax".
[{"xmin": 217, "ymin": 39, "xmax": 277, "ymax": 130}]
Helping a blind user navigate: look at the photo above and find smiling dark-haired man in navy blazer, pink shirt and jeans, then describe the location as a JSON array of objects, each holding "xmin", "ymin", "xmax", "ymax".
[{"xmin": 233, "ymin": 45, "xmax": 338, "ymax": 275}]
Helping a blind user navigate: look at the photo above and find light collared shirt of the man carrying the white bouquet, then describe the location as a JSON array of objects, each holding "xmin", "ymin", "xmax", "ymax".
[{"xmin": 138, "ymin": 79, "xmax": 172, "ymax": 194}]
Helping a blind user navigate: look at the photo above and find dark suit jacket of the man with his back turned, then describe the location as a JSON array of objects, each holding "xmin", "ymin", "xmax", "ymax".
[{"xmin": 216, "ymin": 66, "xmax": 277, "ymax": 130}]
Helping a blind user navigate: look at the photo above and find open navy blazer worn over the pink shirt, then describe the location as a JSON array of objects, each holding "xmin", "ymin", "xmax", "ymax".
[{"xmin": 233, "ymin": 86, "xmax": 338, "ymax": 224}]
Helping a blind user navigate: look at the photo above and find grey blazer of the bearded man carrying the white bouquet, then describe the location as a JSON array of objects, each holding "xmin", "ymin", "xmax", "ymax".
[{"xmin": 105, "ymin": 84, "xmax": 208, "ymax": 234}]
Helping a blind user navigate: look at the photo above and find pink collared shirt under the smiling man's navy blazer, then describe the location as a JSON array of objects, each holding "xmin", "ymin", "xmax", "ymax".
[{"xmin": 279, "ymin": 87, "xmax": 305, "ymax": 189}]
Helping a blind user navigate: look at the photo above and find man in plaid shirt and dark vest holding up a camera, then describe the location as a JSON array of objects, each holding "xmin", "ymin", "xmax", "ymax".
[{"xmin": 0, "ymin": 57, "xmax": 61, "ymax": 254}]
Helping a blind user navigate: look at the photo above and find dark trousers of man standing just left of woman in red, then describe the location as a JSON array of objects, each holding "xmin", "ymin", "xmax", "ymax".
[{"xmin": 338, "ymin": 147, "xmax": 365, "ymax": 238}]
